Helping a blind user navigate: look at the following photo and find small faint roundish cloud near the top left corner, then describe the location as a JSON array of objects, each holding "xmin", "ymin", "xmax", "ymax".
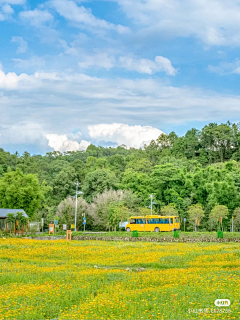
[{"xmin": 19, "ymin": 9, "xmax": 53, "ymax": 27}]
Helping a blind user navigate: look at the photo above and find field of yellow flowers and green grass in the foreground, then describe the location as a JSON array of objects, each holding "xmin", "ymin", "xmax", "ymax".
[{"xmin": 0, "ymin": 239, "xmax": 240, "ymax": 320}]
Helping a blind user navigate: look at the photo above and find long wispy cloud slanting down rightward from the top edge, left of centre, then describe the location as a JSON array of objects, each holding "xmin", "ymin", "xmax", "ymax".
[{"xmin": 50, "ymin": 0, "xmax": 129, "ymax": 33}]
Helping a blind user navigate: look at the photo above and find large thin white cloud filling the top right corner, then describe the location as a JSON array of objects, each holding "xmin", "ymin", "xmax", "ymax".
[{"xmin": 116, "ymin": 0, "xmax": 240, "ymax": 46}]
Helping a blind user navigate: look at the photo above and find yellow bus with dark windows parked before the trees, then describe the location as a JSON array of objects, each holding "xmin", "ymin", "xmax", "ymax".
[{"xmin": 125, "ymin": 215, "xmax": 180, "ymax": 232}]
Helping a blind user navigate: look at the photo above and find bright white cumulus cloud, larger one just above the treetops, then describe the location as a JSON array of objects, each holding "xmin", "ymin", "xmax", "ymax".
[{"xmin": 88, "ymin": 123, "xmax": 163, "ymax": 148}]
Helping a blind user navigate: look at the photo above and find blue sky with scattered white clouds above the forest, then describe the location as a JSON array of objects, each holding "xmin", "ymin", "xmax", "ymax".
[{"xmin": 0, "ymin": 0, "xmax": 240, "ymax": 154}]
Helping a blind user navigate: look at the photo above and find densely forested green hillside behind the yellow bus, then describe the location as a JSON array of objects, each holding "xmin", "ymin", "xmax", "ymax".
[{"xmin": 0, "ymin": 123, "xmax": 240, "ymax": 230}]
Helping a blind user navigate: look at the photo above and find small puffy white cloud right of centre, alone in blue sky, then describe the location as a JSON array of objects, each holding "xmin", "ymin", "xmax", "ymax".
[{"xmin": 119, "ymin": 56, "xmax": 177, "ymax": 76}]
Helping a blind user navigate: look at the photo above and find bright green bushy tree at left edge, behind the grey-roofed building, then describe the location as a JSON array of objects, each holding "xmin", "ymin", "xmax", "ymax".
[{"xmin": 0, "ymin": 169, "xmax": 49, "ymax": 217}]
